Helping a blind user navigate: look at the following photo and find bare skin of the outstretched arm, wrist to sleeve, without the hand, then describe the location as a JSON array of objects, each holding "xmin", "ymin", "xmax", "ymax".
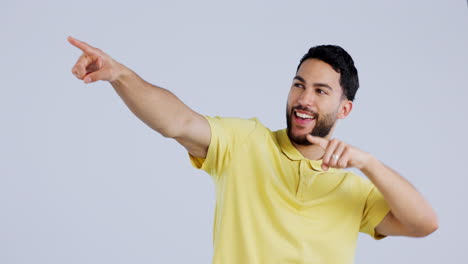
[{"xmin": 110, "ymin": 68, "xmax": 211, "ymax": 158}]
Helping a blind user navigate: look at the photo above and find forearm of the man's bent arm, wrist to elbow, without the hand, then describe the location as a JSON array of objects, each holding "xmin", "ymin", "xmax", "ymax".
[{"xmin": 361, "ymin": 156, "xmax": 438, "ymax": 233}]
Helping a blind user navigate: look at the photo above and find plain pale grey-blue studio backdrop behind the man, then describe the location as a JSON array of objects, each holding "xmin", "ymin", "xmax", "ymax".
[{"xmin": 0, "ymin": 0, "xmax": 468, "ymax": 264}]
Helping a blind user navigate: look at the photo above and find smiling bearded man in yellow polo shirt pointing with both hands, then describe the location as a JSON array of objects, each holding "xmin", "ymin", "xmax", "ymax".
[{"xmin": 68, "ymin": 37, "xmax": 438, "ymax": 264}]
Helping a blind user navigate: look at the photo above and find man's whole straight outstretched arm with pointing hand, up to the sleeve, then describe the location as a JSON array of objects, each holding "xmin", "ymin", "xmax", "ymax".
[{"xmin": 68, "ymin": 37, "xmax": 211, "ymax": 158}]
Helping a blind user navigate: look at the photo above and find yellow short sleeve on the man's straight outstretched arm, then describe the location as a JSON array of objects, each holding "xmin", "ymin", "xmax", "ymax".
[{"xmin": 188, "ymin": 116, "xmax": 258, "ymax": 180}]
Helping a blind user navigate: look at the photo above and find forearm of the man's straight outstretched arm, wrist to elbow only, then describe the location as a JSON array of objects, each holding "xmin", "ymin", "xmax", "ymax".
[{"xmin": 110, "ymin": 64, "xmax": 194, "ymax": 137}]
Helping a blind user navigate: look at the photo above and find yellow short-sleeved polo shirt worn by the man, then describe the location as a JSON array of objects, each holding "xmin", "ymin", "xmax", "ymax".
[{"xmin": 190, "ymin": 116, "xmax": 390, "ymax": 264}]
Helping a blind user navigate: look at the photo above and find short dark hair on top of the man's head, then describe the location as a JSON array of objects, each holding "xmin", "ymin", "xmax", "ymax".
[{"xmin": 296, "ymin": 45, "xmax": 359, "ymax": 101}]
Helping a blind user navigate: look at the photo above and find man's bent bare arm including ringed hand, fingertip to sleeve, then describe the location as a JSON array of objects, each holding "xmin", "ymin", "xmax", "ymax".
[{"xmin": 307, "ymin": 135, "xmax": 438, "ymax": 237}]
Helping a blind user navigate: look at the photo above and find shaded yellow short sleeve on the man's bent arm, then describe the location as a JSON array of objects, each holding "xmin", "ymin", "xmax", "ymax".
[{"xmin": 359, "ymin": 181, "xmax": 390, "ymax": 240}]
